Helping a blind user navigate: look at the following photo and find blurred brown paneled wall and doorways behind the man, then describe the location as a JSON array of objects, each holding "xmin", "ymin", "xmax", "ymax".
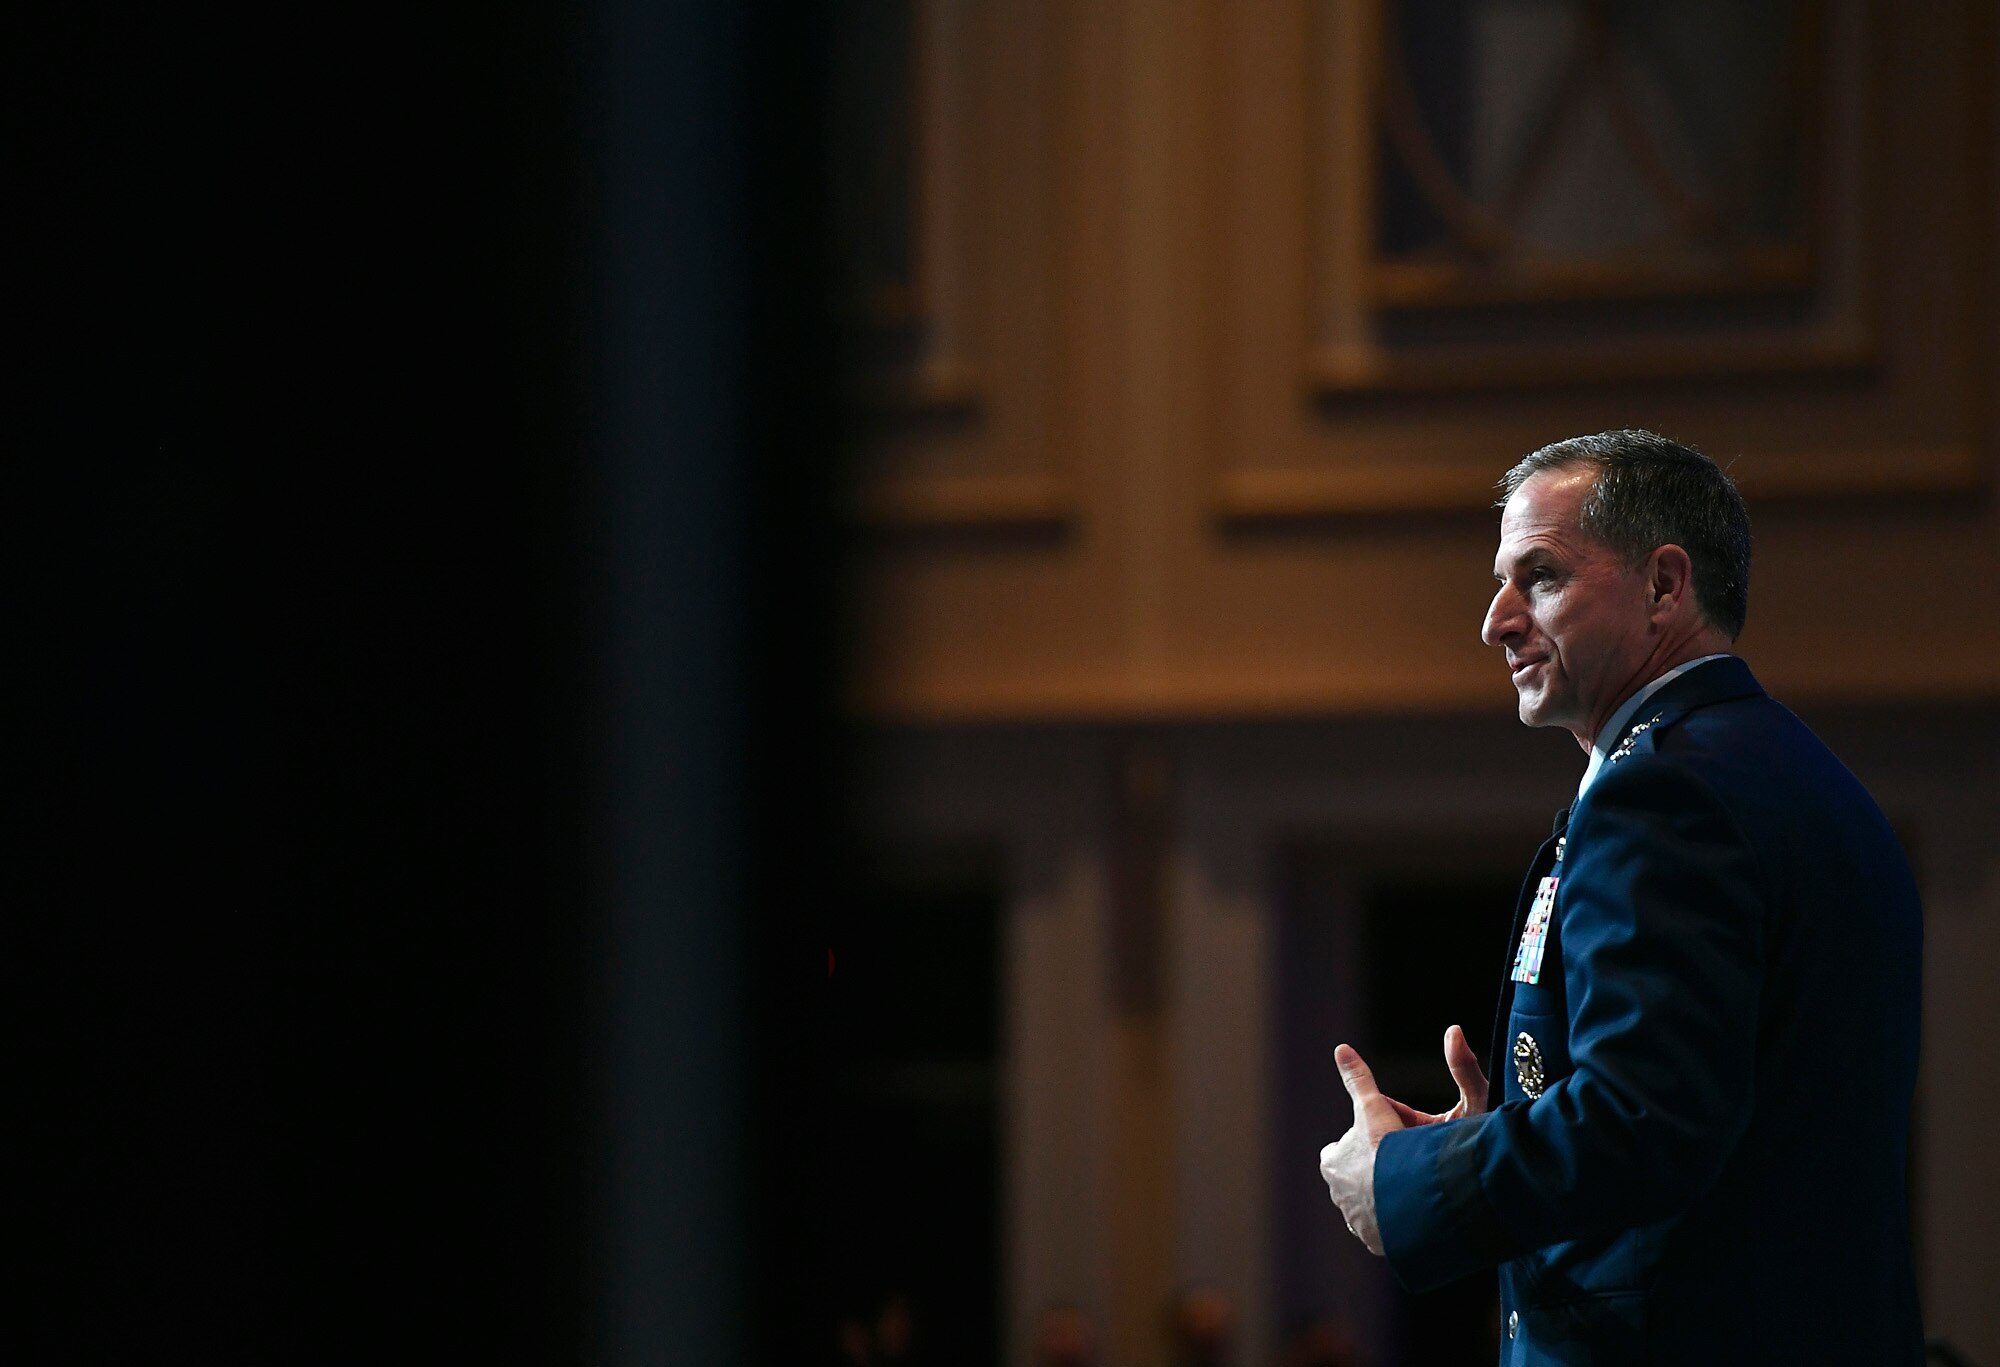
[{"xmin": 828, "ymin": 0, "xmax": 2000, "ymax": 1363}]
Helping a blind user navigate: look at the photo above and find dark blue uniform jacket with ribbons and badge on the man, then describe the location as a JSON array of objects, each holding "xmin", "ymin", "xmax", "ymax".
[{"xmin": 1374, "ymin": 658, "xmax": 1922, "ymax": 1367}]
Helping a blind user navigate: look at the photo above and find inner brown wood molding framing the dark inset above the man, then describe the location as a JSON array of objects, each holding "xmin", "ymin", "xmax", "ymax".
[{"xmin": 1302, "ymin": 0, "xmax": 1882, "ymax": 398}]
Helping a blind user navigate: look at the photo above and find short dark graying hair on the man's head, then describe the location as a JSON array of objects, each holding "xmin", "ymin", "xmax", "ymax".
[{"xmin": 1500, "ymin": 428, "xmax": 1750, "ymax": 642}]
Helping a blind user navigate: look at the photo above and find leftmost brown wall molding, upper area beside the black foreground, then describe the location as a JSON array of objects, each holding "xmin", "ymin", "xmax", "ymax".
[{"xmin": 846, "ymin": 0, "xmax": 1078, "ymax": 530}]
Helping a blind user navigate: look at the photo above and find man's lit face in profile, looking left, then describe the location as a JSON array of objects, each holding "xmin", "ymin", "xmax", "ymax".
[{"xmin": 1480, "ymin": 466, "xmax": 1650, "ymax": 747}]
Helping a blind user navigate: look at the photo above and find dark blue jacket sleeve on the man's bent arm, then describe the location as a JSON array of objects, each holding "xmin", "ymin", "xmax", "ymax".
[{"xmin": 1374, "ymin": 753, "xmax": 1768, "ymax": 1289}]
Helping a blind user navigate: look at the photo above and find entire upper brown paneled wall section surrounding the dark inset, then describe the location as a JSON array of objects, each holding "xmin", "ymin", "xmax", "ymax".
[{"xmin": 854, "ymin": 0, "xmax": 2000, "ymax": 719}]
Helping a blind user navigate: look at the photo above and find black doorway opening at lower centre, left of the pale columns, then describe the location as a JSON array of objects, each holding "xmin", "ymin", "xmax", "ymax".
[{"xmin": 812, "ymin": 851, "xmax": 1004, "ymax": 1367}]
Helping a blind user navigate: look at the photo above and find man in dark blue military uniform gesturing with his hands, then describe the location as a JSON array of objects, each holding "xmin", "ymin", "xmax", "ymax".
[{"xmin": 1320, "ymin": 432, "xmax": 1922, "ymax": 1367}]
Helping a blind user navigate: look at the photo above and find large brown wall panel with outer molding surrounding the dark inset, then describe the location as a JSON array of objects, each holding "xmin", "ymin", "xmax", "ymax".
[{"xmin": 1216, "ymin": 0, "xmax": 1992, "ymax": 520}]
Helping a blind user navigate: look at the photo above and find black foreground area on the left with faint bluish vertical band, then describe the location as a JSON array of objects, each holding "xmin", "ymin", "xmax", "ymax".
[{"xmin": 17, "ymin": 4, "xmax": 840, "ymax": 1361}]
